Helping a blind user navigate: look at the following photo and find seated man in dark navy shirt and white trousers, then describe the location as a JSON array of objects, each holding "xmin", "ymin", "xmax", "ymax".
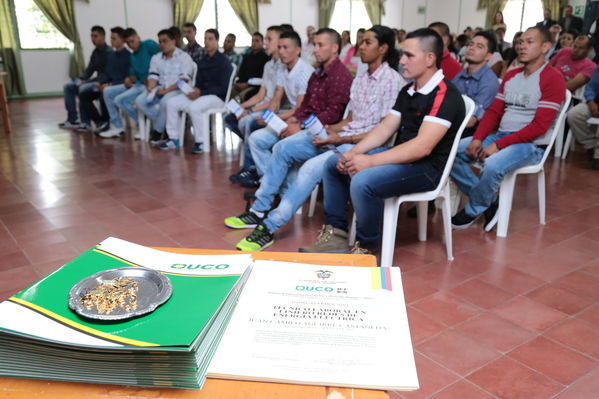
[{"xmin": 160, "ymin": 29, "xmax": 233, "ymax": 154}]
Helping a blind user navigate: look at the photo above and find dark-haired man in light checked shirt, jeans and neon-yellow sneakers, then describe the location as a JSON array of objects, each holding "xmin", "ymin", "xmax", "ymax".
[{"xmin": 225, "ymin": 25, "xmax": 405, "ymax": 251}]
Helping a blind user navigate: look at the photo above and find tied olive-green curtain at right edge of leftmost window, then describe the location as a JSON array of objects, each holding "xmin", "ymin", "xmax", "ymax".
[{"xmin": 33, "ymin": 0, "xmax": 85, "ymax": 77}]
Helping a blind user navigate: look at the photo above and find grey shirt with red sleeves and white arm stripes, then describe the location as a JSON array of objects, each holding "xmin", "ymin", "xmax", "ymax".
[{"xmin": 474, "ymin": 63, "xmax": 566, "ymax": 148}]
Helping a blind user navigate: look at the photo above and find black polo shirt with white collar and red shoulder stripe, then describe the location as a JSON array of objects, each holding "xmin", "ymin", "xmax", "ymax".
[{"xmin": 390, "ymin": 70, "xmax": 466, "ymax": 170}]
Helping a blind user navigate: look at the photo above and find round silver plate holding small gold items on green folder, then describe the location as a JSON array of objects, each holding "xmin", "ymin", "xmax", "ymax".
[{"xmin": 69, "ymin": 267, "xmax": 173, "ymax": 320}]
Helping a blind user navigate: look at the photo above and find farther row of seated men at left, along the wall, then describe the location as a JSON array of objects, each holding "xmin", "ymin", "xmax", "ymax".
[{"xmin": 59, "ymin": 23, "xmax": 269, "ymax": 153}]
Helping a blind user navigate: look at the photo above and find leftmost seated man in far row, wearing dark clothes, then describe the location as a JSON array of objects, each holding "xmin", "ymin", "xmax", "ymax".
[{"xmin": 58, "ymin": 25, "xmax": 112, "ymax": 130}]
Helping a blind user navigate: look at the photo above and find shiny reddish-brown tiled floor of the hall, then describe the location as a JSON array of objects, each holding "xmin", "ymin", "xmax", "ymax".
[{"xmin": 0, "ymin": 99, "xmax": 599, "ymax": 399}]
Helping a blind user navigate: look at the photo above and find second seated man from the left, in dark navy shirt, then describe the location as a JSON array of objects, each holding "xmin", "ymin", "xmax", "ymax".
[{"xmin": 79, "ymin": 26, "xmax": 131, "ymax": 134}]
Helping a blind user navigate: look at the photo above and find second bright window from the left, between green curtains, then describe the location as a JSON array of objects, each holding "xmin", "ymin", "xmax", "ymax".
[{"xmin": 195, "ymin": 0, "xmax": 253, "ymax": 47}]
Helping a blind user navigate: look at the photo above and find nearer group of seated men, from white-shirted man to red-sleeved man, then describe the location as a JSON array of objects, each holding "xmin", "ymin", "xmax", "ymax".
[{"xmin": 224, "ymin": 22, "xmax": 566, "ymax": 253}]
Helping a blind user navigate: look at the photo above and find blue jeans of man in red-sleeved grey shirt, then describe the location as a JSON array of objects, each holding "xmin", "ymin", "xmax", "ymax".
[{"xmin": 451, "ymin": 132, "xmax": 543, "ymax": 217}]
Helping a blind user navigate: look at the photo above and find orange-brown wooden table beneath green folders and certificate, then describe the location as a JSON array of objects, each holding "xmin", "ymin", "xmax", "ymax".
[{"xmin": 0, "ymin": 248, "xmax": 389, "ymax": 399}]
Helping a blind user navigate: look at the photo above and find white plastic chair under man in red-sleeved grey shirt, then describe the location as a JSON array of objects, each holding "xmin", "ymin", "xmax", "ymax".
[{"xmin": 486, "ymin": 90, "xmax": 572, "ymax": 237}]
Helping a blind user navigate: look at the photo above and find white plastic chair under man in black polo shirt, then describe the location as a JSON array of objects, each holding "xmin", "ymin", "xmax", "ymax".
[{"xmin": 350, "ymin": 96, "xmax": 474, "ymax": 267}]
